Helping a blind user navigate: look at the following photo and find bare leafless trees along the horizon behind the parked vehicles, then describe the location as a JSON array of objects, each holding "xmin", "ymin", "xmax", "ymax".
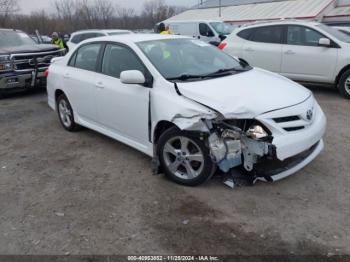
[{"xmin": 0, "ymin": 0, "xmax": 185, "ymax": 34}]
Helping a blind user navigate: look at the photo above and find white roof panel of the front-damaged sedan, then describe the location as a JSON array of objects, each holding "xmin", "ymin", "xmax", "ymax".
[{"xmin": 84, "ymin": 34, "xmax": 192, "ymax": 43}]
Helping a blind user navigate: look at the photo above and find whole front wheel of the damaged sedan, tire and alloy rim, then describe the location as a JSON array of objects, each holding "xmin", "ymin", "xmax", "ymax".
[{"xmin": 158, "ymin": 127, "xmax": 215, "ymax": 186}]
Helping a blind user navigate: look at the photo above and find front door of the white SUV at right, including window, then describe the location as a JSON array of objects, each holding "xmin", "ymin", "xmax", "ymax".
[{"xmin": 281, "ymin": 25, "xmax": 338, "ymax": 82}]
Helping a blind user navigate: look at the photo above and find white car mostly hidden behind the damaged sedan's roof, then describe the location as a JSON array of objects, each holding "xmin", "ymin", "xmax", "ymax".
[{"xmin": 67, "ymin": 29, "xmax": 133, "ymax": 50}]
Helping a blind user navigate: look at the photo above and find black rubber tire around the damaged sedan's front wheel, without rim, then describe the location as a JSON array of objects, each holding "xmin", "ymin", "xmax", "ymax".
[{"xmin": 157, "ymin": 127, "xmax": 215, "ymax": 186}]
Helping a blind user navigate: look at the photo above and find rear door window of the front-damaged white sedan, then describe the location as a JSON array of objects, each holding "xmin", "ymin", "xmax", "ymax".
[{"xmin": 74, "ymin": 44, "xmax": 101, "ymax": 71}]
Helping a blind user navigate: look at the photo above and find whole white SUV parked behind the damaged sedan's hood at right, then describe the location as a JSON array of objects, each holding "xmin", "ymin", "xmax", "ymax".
[{"xmin": 219, "ymin": 20, "xmax": 350, "ymax": 99}]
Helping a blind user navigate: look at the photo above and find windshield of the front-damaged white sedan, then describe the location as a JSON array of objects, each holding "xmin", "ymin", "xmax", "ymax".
[{"xmin": 138, "ymin": 39, "xmax": 250, "ymax": 81}]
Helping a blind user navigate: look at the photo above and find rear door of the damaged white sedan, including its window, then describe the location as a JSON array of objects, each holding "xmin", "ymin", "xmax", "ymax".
[{"xmin": 63, "ymin": 43, "xmax": 102, "ymax": 122}]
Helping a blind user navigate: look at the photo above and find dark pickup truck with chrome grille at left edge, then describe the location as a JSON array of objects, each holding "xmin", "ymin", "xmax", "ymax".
[{"xmin": 0, "ymin": 29, "xmax": 65, "ymax": 96}]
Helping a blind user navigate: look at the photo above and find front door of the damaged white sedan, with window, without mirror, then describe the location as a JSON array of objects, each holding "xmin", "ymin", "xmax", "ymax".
[{"xmin": 96, "ymin": 44, "xmax": 150, "ymax": 145}]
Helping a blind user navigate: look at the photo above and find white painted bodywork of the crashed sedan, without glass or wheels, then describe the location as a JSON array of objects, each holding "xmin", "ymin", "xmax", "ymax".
[{"xmin": 47, "ymin": 34, "xmax": 326, "ymax": 184}]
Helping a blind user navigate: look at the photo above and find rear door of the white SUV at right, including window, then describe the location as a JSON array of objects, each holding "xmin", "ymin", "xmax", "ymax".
[{"xmin": 242, "ymin": 25, "xmax": 283, "ymax": 73}]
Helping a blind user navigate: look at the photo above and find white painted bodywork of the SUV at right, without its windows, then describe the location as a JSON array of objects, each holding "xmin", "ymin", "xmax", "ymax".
[{"xmin": 222, "ymin": 20, "xmax": 350, "ymax": 89}]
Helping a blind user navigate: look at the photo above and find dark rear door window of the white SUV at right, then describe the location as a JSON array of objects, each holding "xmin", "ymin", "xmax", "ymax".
[{"xmin": 251, "ymin": 26, "xmax": 283, "ymax": 44}]
